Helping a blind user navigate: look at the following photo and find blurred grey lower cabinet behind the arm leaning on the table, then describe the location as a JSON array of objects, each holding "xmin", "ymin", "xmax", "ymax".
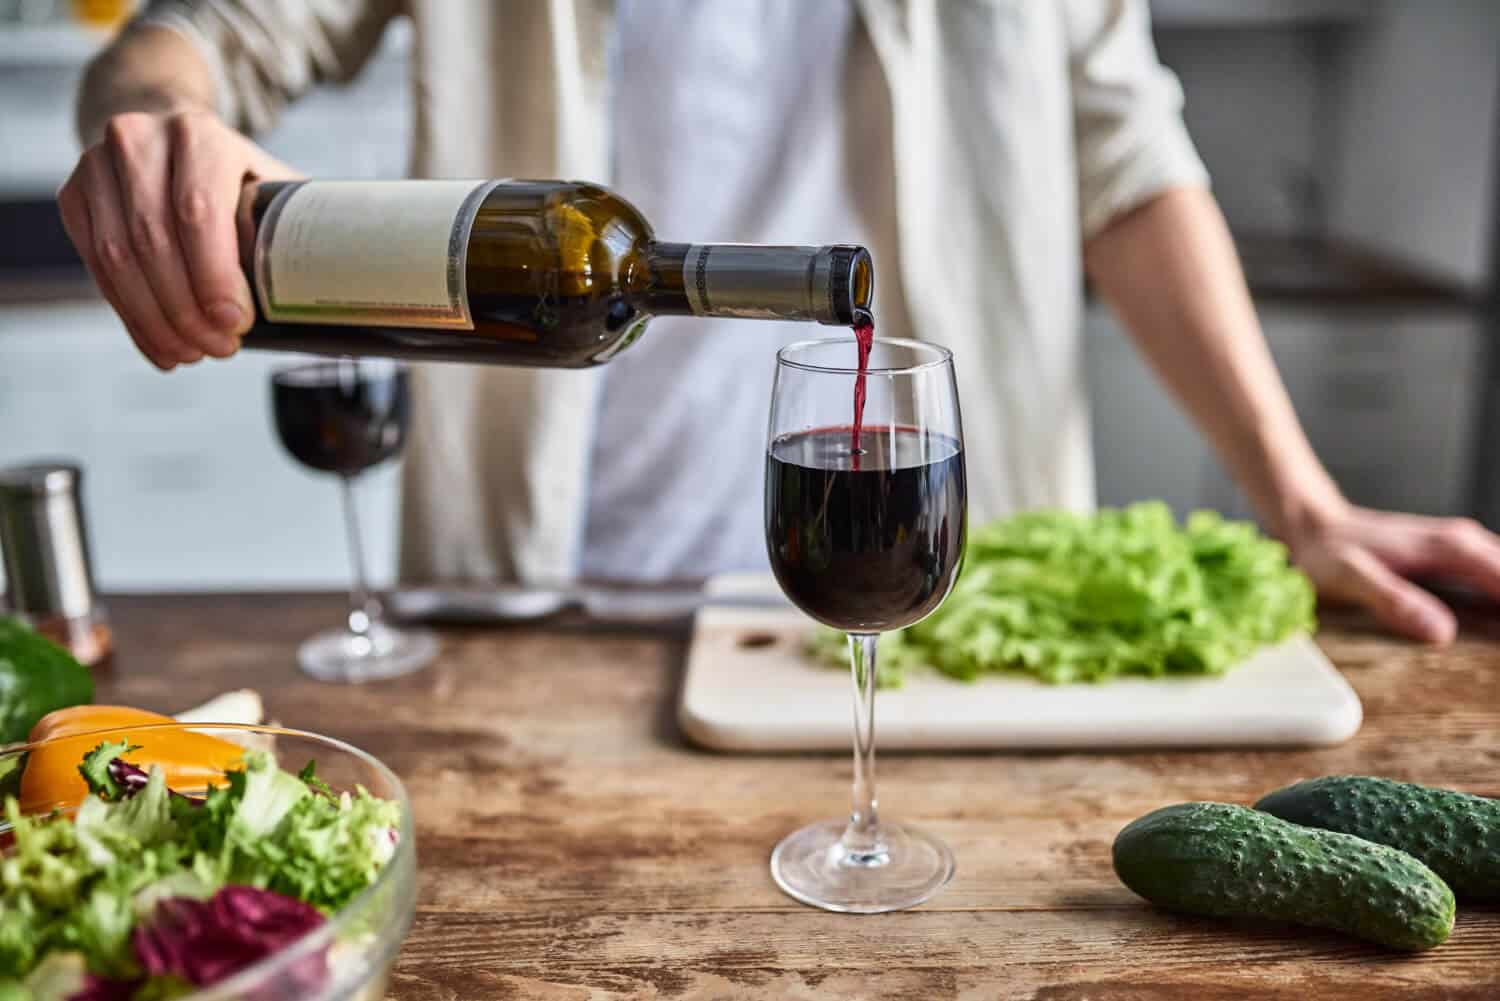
[{"xmin": 1088, "ymin": 303, "xmax": 1484, "ymax": 516}]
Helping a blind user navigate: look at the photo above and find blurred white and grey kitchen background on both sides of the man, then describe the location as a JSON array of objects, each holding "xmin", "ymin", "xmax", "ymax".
[{"xmin": 0, "ymin": 0, "xmax": 1500, "ymax": 590}]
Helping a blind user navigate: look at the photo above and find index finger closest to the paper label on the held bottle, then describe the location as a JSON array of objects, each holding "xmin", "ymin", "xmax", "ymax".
[{"xmin": 168, "ymin": 113, "xmax": 255, "ymax": 345}]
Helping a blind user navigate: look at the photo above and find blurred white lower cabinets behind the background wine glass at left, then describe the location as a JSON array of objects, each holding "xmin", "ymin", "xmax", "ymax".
[{"xmin": 0, "ymin": 302, "xmax": 398, "ymax": 591}]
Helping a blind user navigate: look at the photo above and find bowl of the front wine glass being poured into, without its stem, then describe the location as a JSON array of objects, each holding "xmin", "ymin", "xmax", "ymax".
[{"xmin": 765, "ymin": 339, "xmax": 968, "ymax": 633}]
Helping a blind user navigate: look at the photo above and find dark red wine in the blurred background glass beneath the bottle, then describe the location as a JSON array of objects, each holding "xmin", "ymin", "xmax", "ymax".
[{"xmin": 272, "ymin": 362, "xmax": 411, "ymax": 476}]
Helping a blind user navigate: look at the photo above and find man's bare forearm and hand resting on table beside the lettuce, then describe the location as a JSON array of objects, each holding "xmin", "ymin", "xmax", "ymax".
[{"xmin": 1085, "ymin": 188, "xmax": 1500, "ymax": 642}]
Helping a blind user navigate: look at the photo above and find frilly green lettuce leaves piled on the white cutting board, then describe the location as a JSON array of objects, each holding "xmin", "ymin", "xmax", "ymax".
[{"xmin": 812, "ymin": 501, "xmax": 1316, "ymax": 687}]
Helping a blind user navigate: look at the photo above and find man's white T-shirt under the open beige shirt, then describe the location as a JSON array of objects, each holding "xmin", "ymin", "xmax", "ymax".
[{"xmin": 582, "ymin": 0, "xmax": 897, "ymax": 579}]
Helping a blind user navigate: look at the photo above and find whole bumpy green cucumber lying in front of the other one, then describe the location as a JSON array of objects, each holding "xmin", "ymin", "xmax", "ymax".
[{"xmin": 1115, "ymin": 803, "xmax": 1454, "ymax": 951}]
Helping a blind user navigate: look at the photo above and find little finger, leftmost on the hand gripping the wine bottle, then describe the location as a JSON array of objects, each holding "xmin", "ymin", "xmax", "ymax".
[{"xmin": 80, "ymin": 147, "xmax": 203, "ymax": 368}]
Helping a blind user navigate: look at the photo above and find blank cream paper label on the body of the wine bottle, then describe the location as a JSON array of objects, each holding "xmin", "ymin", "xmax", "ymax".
[{"xmin": 255, "ymin": 180, "xmax": 498, "ymax": 330}]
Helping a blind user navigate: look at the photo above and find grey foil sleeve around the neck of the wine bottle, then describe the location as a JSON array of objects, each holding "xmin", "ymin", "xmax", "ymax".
[{"xmin": 683, "ymin": 243, "xmax": 827, "ymax": 320}]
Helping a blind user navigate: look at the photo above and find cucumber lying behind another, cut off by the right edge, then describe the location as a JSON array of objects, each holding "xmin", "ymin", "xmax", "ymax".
[{"xmin": 1256, "ymin": 776, "xmax": 1500, "ymax": 900}]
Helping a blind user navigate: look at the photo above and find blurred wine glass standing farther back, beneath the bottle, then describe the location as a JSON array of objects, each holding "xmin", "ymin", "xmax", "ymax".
[{"xmin": 272, "ymin": 359, "xmax": 438, "ymax": 681}]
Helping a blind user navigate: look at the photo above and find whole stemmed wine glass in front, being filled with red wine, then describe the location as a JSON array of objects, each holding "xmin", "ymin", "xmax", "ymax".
[{"xmin": 765, "ymin": 339, "xmax": 968, "ymax": 914}]
